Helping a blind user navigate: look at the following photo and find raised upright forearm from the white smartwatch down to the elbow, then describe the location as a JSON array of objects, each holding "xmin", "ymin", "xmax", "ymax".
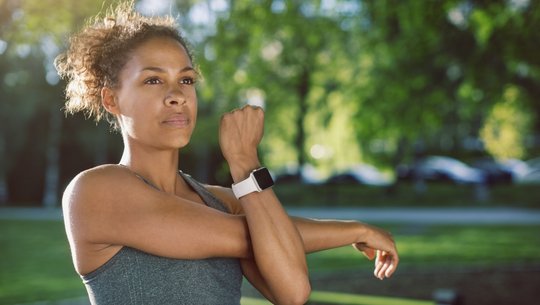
[{"xmin": 231, "ymin": 164, "xmax": 310, "ymax": 304}]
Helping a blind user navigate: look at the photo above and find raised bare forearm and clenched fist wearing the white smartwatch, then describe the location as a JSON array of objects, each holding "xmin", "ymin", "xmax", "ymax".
[{"xmin": 220, "ymin": 106, "xmax": 311, "ymax": 304}]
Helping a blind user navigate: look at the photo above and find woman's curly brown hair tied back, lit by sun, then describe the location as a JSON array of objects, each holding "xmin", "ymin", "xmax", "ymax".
[{"xmin": 54, "ymin": 1, "xmax": 193, "ymax": 129}]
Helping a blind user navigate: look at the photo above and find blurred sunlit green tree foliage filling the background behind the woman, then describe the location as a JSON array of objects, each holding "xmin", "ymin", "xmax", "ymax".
[{"xmin": 0, "ymin": 0, "xmax": 540, "ymax": 201}]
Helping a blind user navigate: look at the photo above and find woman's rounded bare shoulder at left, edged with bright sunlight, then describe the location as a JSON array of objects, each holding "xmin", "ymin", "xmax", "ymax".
[{"xmin": 62, "ymin": 164, "xmax": 165, "ymax": 244}]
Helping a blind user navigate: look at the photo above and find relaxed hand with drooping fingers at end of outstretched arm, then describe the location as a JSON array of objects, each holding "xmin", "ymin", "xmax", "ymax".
[{"xmin": 353, "ymin": 226, "xmax": 399, "ymax": 280}]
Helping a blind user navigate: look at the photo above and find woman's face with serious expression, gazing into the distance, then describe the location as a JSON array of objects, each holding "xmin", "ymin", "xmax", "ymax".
[{"xmin": 114, "ymin": 38, "xmax": 198, "ymax": 149}]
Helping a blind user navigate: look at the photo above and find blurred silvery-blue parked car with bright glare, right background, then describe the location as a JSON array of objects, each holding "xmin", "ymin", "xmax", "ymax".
[{"xmin": 397, "ymin": 156, "xmax": 487, "ymax": 184}]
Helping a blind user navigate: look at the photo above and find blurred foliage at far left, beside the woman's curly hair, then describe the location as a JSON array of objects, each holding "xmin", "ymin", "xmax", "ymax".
[{"xmin": 0, "ymin": 0, "xmax": 121, "ymax": 204}]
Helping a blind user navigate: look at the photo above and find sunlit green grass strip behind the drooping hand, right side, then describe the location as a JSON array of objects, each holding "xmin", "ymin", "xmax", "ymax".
[{"xmin": 308, "ymin": 225, "xmax": 540, "ymax": 273}]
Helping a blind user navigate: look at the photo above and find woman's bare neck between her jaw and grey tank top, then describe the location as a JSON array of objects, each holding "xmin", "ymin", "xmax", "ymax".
[{"xmin": 120, "ymin": 140, "xmax": 179, "ymax": 194}]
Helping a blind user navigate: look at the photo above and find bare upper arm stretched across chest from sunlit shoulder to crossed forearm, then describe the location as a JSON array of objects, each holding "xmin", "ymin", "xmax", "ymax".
[{"xmin": 63, "ymin": 166, "xmax": 252, "ymax": 273}]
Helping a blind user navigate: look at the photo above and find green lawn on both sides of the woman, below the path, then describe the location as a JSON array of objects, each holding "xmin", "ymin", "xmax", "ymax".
[{"xmin": 0, "ymin": 220, "xmax": 540, "ymax": 305}]
